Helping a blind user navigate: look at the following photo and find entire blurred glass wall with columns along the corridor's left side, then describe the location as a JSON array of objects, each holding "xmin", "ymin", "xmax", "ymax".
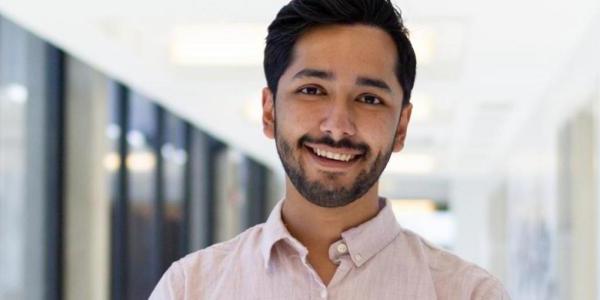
[{"xmin": 0, "ymin": 14, "xmax": 279, "ymax": 299}]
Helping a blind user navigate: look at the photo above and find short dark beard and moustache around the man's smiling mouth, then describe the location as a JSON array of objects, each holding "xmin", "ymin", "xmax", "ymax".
[{"xmin": 275, "ymin": 124, "xmax": 395, "ymax": 207}]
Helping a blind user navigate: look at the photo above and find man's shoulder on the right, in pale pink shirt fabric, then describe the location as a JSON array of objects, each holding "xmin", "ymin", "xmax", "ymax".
[{"xmin": 403, "ymin": 229, "xmax": 509, "ymax": 299}]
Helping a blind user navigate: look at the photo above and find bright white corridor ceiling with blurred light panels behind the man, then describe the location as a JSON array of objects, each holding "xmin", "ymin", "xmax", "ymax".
[{"xmin": 0, "ymin": 0, "xmax": 599, "ymax": 197}]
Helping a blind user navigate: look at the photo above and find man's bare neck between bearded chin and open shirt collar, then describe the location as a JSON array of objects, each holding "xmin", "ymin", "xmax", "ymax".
[{"xmin": 281, "ymin": 178, "xmax": 379, "ymax": 251}]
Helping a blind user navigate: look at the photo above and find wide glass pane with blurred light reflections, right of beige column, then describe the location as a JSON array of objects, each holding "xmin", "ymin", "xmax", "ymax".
[{"xmin": 126, "ymin": 93, "xmax": 161, "ymax": 299}]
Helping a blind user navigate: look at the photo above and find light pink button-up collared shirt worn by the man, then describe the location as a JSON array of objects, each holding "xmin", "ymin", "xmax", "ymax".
[{"xmin": 150, "ymin": 200, "xmax": 509, "ymax": 300}]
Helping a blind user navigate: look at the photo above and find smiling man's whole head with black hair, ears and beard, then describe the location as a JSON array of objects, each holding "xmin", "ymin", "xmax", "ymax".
[{"xmin": 263, "ymin": 0, "xmax": 416, "ymax": 207}]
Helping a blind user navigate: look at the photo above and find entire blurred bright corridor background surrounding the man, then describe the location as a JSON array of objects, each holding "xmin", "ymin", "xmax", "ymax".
[{"xmin": 0, "ymin": 0, "xmax": 600, "ymax": 299}]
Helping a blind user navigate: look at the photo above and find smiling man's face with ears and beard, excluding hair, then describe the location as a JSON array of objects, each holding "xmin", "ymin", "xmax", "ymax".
[{"xmin": 263, "ymin": 25, "xmax": 411, "ymax": 207}]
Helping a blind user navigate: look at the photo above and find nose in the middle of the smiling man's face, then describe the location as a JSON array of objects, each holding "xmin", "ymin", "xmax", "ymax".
[{"xmin": 320, "ymin": 101, "xmax": 356, "ymax": 141}]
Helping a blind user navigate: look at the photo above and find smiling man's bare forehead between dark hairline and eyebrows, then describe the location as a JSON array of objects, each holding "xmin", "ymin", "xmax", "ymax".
[{"xmin": 285, "ymin": 25, "xmax": 399, "ymax": 88}]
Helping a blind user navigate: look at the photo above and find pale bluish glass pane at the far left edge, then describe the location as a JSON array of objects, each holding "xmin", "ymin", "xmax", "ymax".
[{"xmin": 0, "ymin": 18, "xmax": 63, "ymax": 299}]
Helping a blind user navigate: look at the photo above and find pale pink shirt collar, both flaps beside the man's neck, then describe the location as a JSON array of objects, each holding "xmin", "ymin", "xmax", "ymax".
[{"xmin": 260, "ymin": 198, "xmax": 401, "ymax": 268}]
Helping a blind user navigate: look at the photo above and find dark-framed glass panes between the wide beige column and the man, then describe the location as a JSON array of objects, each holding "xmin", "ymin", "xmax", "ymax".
[{"xmin": 105, "ymin": 89, "xmax": 268, "ymax": 299}]
